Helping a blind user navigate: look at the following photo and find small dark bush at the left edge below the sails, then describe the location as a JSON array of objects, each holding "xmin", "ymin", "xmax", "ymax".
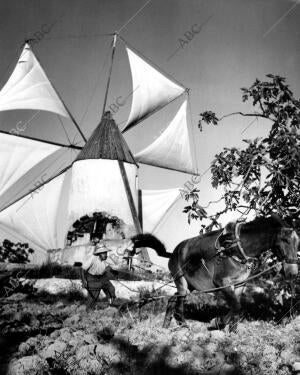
[{"xmin": 0, "ymin": 239, "xmax": 34, "ymax": 263}]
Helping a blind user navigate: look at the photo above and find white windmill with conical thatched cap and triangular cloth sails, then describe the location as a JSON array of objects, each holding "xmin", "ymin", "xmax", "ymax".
[{"xmin": 0, "ymin": 34, "xmax": 197, "ymax": 270}]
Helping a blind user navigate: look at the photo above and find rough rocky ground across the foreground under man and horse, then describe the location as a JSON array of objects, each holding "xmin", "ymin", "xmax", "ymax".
[{"xmin": 0, "ymin": 284, "xmax": 300, "ymax": 375}]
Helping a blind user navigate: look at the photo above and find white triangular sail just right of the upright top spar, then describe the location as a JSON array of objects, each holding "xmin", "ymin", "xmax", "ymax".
[{"xmin": 123, "ymin": 47, "xmax": 185, "ymax": 132}]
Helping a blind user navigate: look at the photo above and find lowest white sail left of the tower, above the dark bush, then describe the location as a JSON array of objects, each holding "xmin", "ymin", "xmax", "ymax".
[{"xmin": 0, "ymin": 172, "xmax": 70, "ymax": 252}]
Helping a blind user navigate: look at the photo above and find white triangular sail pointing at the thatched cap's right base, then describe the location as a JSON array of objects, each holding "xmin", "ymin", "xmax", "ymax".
[{"xmin": 135, "ymin": 101, "xmax": 196, "ymax": 174}]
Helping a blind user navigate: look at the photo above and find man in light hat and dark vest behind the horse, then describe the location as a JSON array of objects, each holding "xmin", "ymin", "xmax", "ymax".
[{"xmin": 81, "ymin": 244, "xmax": 116, "ymax": 310}]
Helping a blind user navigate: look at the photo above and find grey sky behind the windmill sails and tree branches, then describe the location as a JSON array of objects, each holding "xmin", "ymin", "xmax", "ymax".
[{"xmin": 0, "ymin": 0, "xmax": 300, "ymax": 264}]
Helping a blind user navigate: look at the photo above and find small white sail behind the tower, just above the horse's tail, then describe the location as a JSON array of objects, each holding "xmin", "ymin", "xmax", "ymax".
[{"xmin": 141, "ymin": 189, "xmax": 180, "ymax": 233}]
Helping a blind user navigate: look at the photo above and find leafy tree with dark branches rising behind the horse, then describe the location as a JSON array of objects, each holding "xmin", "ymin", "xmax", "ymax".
[{"xmin": 184, "ymin": 74, "xmax": 300, "ymax": 231}]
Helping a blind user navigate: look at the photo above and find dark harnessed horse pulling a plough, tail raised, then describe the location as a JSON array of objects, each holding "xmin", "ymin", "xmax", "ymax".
[{"xmin": 132, "ymin": 215, "xmax": 299, "ymax": 330}]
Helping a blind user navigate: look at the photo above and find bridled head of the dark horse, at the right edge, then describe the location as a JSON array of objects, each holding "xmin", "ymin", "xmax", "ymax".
[{"xmin": 274, "ymin": 227, "xmax": 299, "ymax": 279}]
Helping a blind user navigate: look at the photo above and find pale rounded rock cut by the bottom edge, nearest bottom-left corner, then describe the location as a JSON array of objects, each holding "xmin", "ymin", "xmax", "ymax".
[{"xmin": 8, "ymin": 355, "xmax": 48, "ymax": 375}]
